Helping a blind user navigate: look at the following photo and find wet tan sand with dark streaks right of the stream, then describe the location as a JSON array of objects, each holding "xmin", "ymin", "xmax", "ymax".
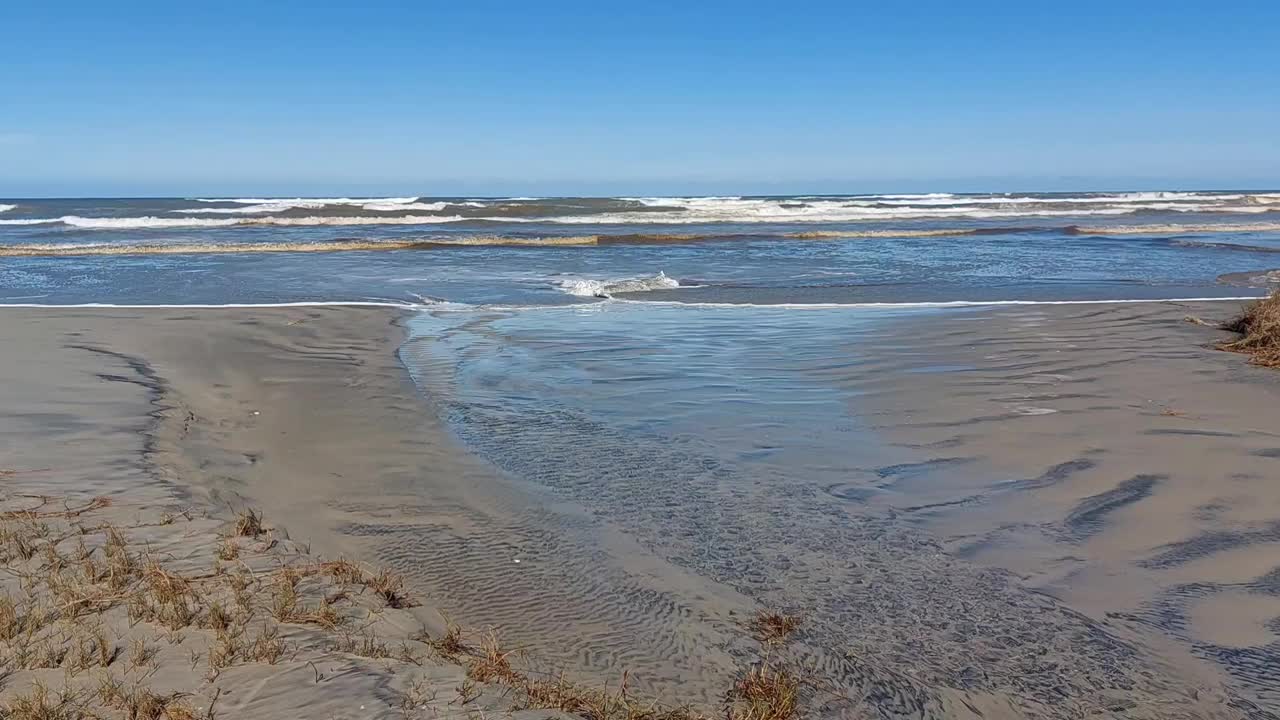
[{"xmin": 837, "ymin": 302, "xmax": 1280, "ymax": 716}]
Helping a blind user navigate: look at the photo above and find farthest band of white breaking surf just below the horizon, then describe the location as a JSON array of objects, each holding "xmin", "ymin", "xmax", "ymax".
[{"xmin": 10, "ymin": 192, "xmax": 1280, "ymax": 228}]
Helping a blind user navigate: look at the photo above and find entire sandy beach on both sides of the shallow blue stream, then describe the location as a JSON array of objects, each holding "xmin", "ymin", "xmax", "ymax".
[{"xmin": 0, "ymin": 304, "xmax": 1280, "ymax": 717}]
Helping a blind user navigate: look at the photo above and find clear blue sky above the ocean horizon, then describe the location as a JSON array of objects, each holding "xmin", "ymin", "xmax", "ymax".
[{"xmin": 0, "ymin": 0, "xmax": 1280, "ymax": 196}]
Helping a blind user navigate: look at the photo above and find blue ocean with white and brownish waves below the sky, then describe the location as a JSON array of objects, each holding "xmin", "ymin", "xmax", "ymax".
[{"xmin": 0, "ymin": 192, "xmax": 1280, "ymax": 306}]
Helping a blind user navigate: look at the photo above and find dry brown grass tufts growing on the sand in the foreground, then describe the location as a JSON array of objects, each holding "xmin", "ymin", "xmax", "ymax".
[{"xmin": 0, "ymin": 498, "xmax": 805, "ymax": 720}]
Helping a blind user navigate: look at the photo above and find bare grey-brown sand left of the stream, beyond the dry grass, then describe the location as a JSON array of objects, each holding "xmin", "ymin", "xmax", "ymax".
[{"xmin": 0, "ymin": 307, "xmax": 756, "ymax": 717}]
